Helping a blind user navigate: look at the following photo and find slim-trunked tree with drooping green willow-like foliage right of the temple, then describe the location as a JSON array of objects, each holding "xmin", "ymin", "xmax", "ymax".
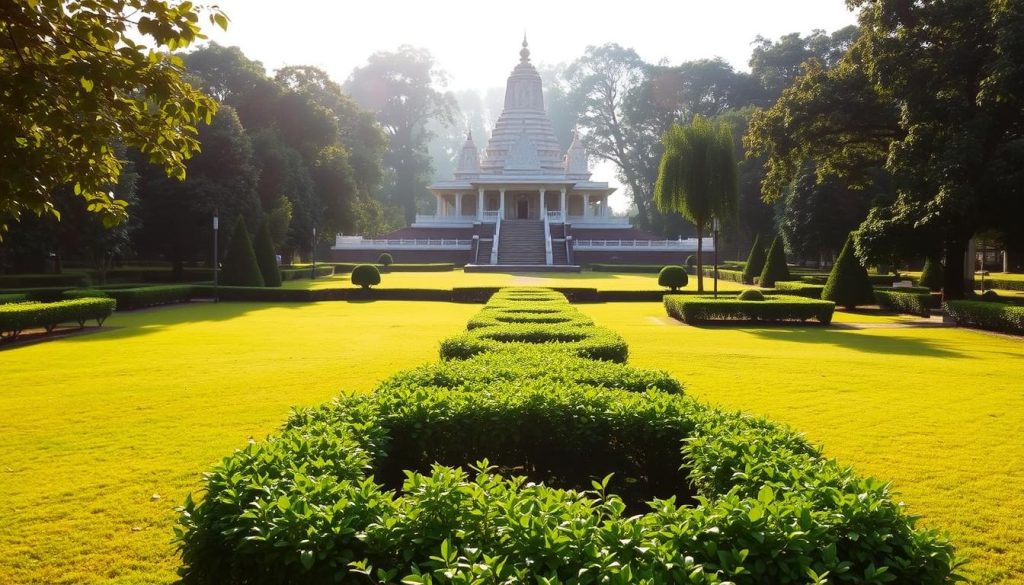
[{"xmin": 654, "ymin": 116, "xmax": 738, "ymax": 292}]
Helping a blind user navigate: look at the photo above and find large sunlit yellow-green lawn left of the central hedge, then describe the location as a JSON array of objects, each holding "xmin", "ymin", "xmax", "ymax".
[{"xmin": 0, "ymin": 302, "xmax": 479, "ymax": 585}]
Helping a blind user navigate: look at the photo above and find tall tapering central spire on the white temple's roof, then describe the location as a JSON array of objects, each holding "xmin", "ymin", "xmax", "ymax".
[{"xmin": 480, "ymin": 38, "xmax": 565, "ymax": 175}]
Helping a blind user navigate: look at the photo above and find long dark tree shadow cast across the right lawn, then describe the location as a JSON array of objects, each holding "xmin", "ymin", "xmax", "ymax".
[{"xmin": 745, "ymin": 326, "xmax": 968, "ymax": 358}]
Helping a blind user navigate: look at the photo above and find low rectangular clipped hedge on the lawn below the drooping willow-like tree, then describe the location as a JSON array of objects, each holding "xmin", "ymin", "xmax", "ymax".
[{"xmin": 665, "ymin": 295, "xmax": 836, "ymax": 325}]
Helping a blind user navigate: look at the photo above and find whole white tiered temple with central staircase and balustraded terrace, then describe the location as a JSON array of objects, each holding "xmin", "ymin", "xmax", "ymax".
[{"xmin": 332, "ymin": 38, "xmax": 712, "ymax": 270}]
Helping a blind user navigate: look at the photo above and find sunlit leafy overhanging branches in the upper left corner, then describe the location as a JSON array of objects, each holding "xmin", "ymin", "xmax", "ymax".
[{"xmin": 0, "ymin": 0, "xmax": 227, "ymax": 238}]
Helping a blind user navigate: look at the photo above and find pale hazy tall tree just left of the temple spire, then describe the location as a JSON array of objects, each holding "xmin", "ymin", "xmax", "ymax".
[{"xmin": 345, "ymin": 45, "xmax": 456, "ymax": 221}]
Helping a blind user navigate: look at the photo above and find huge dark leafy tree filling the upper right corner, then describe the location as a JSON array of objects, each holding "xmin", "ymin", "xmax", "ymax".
[{"xmin": 750, "ymin": 0, "xmax": 1024, "ymax": 298}]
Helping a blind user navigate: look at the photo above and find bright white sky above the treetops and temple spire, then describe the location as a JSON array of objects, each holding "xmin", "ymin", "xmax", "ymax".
[{"xmin": 199, "ymin": 0, "xmax": 856, "ymax": 210}]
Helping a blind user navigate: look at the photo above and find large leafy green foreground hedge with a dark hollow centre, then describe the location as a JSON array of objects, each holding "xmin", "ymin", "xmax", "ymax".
[{"xmin": 176, "ymin": 286, "xmax": 956, "ymax": 585}]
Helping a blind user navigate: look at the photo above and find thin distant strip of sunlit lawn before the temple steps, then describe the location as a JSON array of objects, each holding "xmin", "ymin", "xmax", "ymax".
[{"xmin": 283, "ymin": 269, "xmax": 745, "ymax": 291}]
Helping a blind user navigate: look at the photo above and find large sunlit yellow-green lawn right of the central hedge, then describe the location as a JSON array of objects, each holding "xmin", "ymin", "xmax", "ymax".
[{"xmin": 580, "ymin": 303, "xmax": 1024, "ymax": 584}]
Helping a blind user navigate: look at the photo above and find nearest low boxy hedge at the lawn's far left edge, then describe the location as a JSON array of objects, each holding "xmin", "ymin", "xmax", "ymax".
[{"xmin": 0, "ymin": 298, "xmax": 116, "ymax": 339}]
